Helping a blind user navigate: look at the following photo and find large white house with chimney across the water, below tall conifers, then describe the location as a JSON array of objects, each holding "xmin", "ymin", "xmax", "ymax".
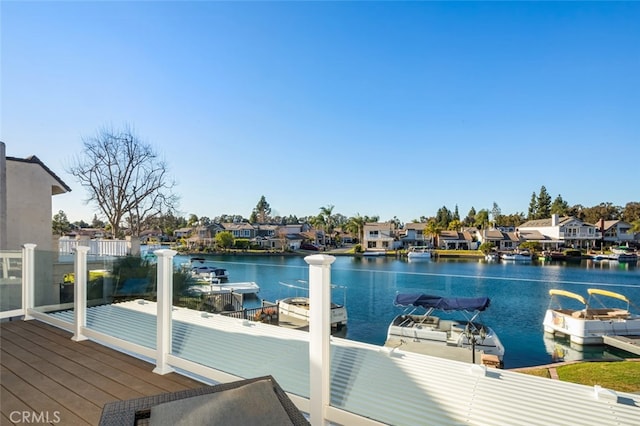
[{"xmin": 516, "ymin": 214, "xmax": 600, "ymax": 249}]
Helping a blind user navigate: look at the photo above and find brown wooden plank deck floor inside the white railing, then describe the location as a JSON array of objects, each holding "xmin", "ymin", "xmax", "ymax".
[{"xmin": 0, "ymin": 320, "xmax": 204, "ymax": 425}]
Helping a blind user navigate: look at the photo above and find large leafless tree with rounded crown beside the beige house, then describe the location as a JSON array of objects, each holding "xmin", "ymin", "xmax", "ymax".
[{"xmin": 67, "ymin": 126, "xmax": 178, "ymax": 238}]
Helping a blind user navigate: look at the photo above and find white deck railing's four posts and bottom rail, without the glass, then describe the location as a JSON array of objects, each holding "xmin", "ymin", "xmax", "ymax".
[{"xmin": 13, "ymin": 244, "xmax": 340, "ymax": 426}]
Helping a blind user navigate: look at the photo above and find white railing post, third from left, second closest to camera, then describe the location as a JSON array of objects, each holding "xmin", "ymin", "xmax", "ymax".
[{"xmin": 153, "ymin": 249, "xmax": 178, "ymax": 374}]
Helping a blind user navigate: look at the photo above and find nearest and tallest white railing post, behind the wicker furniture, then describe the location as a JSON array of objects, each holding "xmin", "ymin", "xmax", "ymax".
[{"xmin": 304, "ymin": 254, "xmax": 336, "ymax": 426}]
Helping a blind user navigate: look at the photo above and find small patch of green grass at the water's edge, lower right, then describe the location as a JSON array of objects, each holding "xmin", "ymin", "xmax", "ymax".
[{"xmin": 523, "ymin": 361, "xmax": 640, "ymax": 392}]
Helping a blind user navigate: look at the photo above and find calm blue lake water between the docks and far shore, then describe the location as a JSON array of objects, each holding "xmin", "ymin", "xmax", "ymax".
[{"xmin": 176, "ymin": 256, "xmax": 640, "ymax": 368}]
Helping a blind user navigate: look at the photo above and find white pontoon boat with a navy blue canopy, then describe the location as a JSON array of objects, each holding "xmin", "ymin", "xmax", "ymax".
[{"xmin": 385, "ymin": 293, "xmax": 504, "ymax": 367}]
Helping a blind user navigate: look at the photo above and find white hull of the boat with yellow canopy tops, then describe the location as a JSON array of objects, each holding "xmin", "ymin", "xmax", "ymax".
[{"xmin": 543, "ymin": 309, "xmax": 640, "ymax": 345}]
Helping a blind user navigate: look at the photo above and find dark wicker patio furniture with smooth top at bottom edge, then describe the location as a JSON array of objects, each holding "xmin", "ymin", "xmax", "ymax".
[{"xmin": 100, "ymin": 376, "xmax": 310, "ymax": 426}]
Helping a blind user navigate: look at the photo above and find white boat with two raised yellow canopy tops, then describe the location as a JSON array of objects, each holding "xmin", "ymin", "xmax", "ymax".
[{"xmin": 543, "ymin": 288, "xmax": 640, "ymax": 345}]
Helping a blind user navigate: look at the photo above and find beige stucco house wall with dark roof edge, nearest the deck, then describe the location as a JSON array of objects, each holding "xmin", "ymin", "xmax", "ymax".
[{"xmin": 0, "ymin": 142, "xmax": 71, "ymax": 251}]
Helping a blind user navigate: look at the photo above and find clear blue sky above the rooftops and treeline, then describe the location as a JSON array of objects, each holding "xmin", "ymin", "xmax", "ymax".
[{"xmin": 0, "ymin": 1, "xmax": 640, "ymax": 222}]
